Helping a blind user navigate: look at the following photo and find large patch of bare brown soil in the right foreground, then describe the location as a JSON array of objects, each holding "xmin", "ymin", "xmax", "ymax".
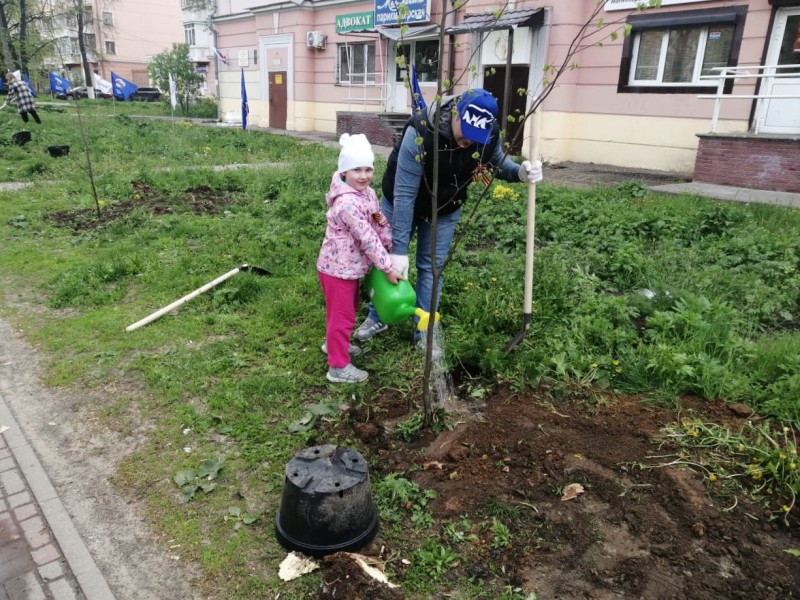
[{"xmin": 340, "ymin": 389, "xmax": 800, "ymax": 600}]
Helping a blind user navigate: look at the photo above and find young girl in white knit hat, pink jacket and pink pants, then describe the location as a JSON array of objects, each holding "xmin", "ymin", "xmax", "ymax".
[{"xmin": 317, "ymin": 133, "xmax": 398, "ymax": 383}]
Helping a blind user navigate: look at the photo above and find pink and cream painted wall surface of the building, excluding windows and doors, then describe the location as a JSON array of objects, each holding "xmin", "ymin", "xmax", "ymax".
[{"xmin": 212, "ymin": 0, "xmax": 771, "ymax": 172}]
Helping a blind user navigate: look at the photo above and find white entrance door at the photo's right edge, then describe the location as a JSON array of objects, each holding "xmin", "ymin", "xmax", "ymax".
[{"xmin": 757, "ymin": 8, "xmax": 800, "ymax": 134}]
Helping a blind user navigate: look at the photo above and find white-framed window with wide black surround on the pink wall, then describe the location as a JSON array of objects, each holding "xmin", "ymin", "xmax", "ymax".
[{"xmin": 619, "ymin": 6, "xmax": 747, "ymax": 94}]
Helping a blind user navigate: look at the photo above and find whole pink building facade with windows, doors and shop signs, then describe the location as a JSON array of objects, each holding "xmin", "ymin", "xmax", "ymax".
[{"xmin": 214, "ymin": 0, "xmax": 800, "ymax": 182}]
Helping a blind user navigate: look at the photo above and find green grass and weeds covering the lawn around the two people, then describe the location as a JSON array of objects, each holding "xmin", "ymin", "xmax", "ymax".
[{"xmin": 0, "ymin": 110, "xmax": 800, "ymax": 599}]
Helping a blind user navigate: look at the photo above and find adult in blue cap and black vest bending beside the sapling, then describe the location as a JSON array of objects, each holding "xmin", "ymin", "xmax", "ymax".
[{"xmin": 355, "ymin": 88, "xmax": 542, "ymax": 345}]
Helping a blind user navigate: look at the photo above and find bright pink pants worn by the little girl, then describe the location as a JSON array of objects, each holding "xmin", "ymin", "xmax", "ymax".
[{"xmin": 319, "ymin": 273, "xmax": 358, "ymax": 369}]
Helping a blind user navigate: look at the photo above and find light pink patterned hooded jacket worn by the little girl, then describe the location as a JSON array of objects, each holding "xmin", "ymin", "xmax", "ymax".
[{"xmin": 317, "ymin": 173, "xmax": 392, "ymax": 279}]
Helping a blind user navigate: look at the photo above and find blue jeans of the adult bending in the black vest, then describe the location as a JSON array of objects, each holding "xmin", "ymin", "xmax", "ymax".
[{"xmin": 369, "ymin": 198, "xmax": 461, "ymax": 337}]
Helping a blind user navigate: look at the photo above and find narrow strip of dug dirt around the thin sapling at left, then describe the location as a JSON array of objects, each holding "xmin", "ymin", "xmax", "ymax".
[{"xmin": 45, "ymin": 181, "xmax": 234, "ymax": 232}]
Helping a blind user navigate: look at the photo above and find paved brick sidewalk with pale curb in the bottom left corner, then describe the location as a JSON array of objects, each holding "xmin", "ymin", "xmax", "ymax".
[{"xmin": 0, "ymin": 390, "xmax": 114, "ymax": 600}]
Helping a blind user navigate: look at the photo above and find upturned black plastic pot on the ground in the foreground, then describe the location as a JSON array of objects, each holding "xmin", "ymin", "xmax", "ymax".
[{"xmin": 275, "ymin": 444, "xmax": 378, "ymax": 557}]
